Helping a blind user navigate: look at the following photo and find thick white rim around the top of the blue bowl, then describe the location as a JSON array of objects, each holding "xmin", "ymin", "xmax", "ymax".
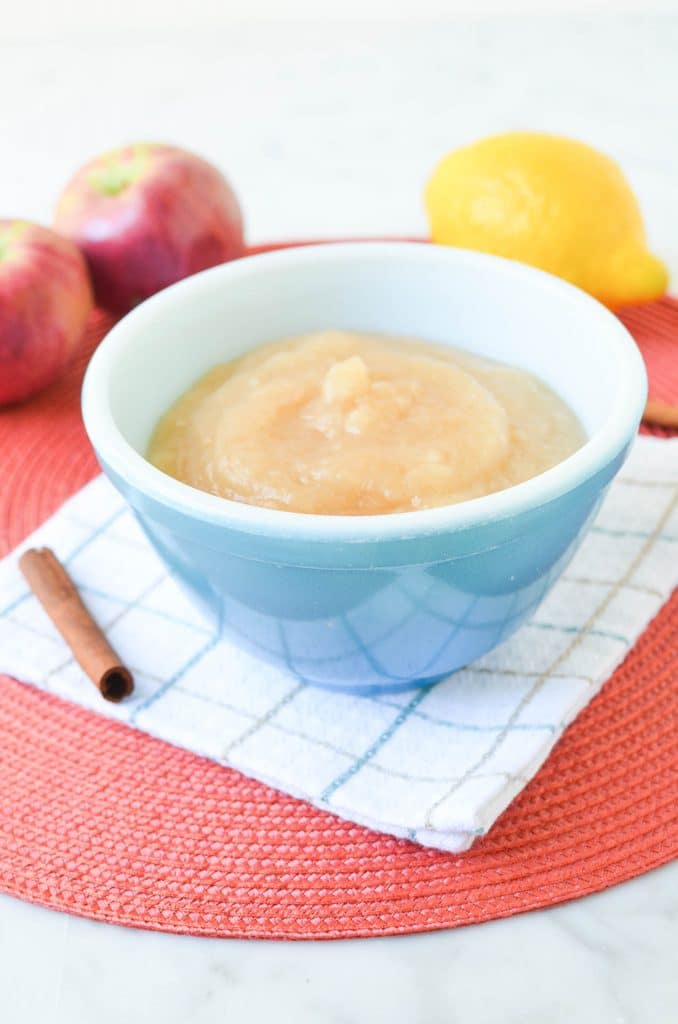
[{"xmin": 82, "ymin": 241, "xmax": 647, "ymax": 543}]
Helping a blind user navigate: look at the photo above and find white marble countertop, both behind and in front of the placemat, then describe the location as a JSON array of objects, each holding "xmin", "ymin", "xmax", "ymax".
[{"xmin": 0, "ymin": 9, "xmax": 678, "ymax": 1024}]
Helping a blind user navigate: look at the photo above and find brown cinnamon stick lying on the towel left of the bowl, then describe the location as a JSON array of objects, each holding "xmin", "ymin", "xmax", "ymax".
[{"xmin": 18, "ymin": 548, "xmax": 134, "ymax": 703}]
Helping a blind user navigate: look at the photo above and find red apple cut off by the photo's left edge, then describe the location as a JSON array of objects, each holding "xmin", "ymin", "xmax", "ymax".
[{"xmin": 0, "ymin": 220, "xmax": 93, "ymax": 406}]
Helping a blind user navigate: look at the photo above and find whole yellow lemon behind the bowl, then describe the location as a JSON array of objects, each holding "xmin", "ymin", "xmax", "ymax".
[{"xmin": 425, "ymin": 132, "xmax": 668, "ymax": 306}]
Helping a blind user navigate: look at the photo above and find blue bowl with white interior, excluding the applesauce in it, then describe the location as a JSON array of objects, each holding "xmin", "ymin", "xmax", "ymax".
[{"xmin": 83, "ymin": 243, "xmax": 646, "ymax": 692}]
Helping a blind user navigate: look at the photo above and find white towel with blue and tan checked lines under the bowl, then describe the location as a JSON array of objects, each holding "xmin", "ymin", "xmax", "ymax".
[{"xmin": 0, "ymin": 437, "xmax": 678, "ymax": 851}]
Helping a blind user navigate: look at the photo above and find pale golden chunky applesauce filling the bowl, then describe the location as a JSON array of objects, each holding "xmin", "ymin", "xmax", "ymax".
[{"xmin": 147, "ymin": 331, "xmax": 586, "ymax": 515}]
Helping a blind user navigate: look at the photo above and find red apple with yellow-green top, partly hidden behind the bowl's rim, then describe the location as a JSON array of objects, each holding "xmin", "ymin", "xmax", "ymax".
[{"xmin": 54, "ymin": 142, "xmax": 244, "ymax": 313}]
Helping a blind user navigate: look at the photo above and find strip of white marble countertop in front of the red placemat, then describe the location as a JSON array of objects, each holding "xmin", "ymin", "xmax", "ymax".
[{"xmin": 0, "ymin": 864, "xmax": 678, "ymax": 1024}]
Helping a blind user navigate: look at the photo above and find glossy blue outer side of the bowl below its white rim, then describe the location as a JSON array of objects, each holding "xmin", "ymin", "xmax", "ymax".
[{"xmin": 104, "ymin": 457, "xmax": 623, "ymax": 693}]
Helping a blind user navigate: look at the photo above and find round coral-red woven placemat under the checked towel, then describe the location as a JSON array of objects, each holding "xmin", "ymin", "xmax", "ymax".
[{"xmin": 0, "ymin": 243, "xmax": 678, "ymax": 938}]
